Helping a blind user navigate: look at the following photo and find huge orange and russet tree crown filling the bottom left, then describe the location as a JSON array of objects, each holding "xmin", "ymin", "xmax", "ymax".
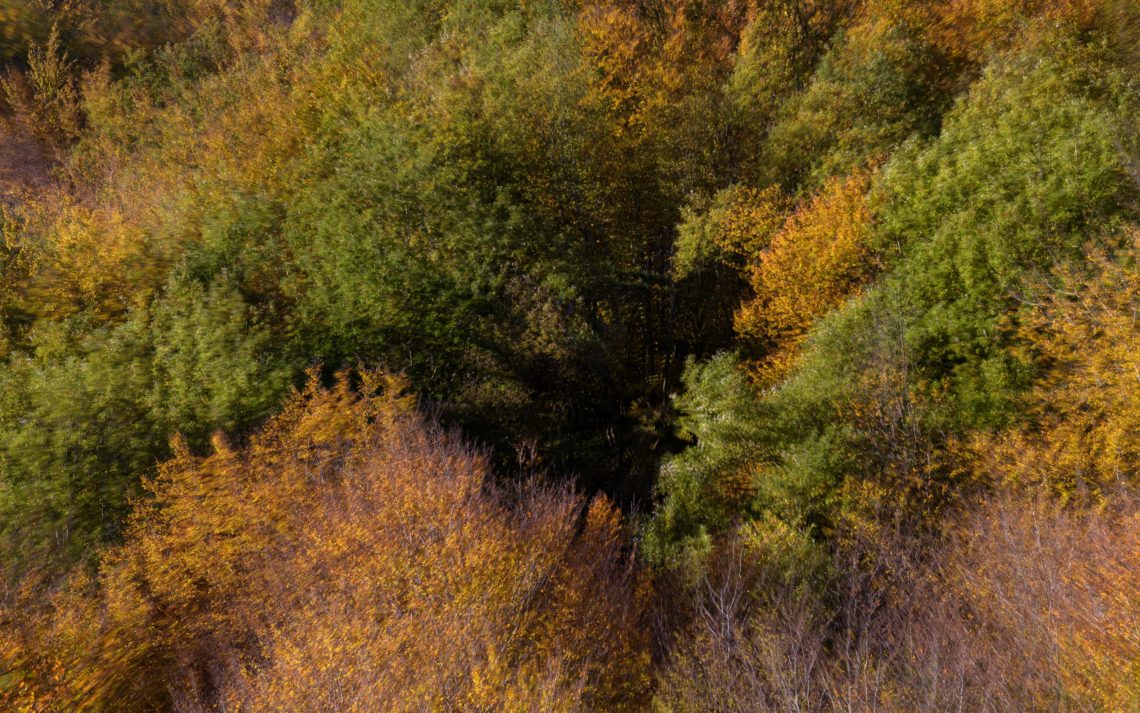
[{"xmin": 0, "ymin": 373, "xmax": 649, "ymax": 711}]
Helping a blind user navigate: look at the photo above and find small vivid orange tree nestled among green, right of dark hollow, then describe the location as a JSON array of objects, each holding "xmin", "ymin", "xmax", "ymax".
[{"xmin": 736, "ymin": 166, "xmax": 874, "ymax": 381}]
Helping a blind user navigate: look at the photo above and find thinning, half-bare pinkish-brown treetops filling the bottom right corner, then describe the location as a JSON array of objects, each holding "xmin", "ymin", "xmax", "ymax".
[{"xmin": 654, "ymin": 488, "xmax": 1140, "ymax": 713}]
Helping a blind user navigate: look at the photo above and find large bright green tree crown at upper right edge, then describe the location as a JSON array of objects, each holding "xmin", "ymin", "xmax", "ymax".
[{"xmin": 880, "ymin": 34, "xmax": 1138, "ymax": 424}]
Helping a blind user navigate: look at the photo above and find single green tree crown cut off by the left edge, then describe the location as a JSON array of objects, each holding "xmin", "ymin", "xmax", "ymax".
[{"xmin": 0, "ymin": 318, "xmax": 162, "ymax": 574}]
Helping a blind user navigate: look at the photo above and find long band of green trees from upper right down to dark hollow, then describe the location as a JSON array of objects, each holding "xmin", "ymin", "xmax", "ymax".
[{"xmin": 649, "ymin": 26, "xmax": 1137, "ymax": 568}]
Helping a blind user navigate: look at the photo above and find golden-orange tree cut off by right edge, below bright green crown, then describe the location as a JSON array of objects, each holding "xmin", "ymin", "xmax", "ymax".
[{"xmin": 975, "ymin": 232, "xmax": 1140, "ymax": 495}]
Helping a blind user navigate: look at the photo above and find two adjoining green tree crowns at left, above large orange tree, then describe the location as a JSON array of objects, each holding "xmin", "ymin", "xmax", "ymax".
[{"xmin": 0, "ymin": 272, "xmax": 291, "ymax": 575}]
